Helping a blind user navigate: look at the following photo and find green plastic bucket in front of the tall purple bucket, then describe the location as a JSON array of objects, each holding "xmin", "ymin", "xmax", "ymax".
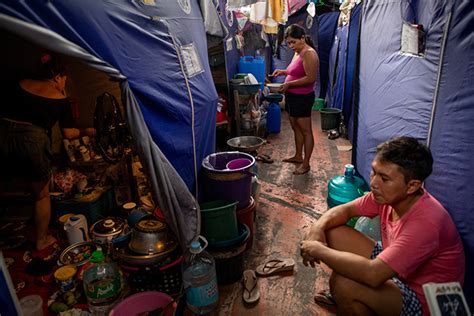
[{"xmin": 200, "ymin": 200, "xmax": 239, "ymax": 243}]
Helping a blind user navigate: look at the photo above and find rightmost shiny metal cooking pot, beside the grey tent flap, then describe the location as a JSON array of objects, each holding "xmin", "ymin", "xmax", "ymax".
[{"xmin": 128, "ymin": 219, "xmax": 168, "ymax": 255}]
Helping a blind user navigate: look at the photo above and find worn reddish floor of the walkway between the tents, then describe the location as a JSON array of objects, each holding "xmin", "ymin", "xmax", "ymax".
[{"xmin": 212, "ymin": 111, "xmax": 351, "ymax": 315}]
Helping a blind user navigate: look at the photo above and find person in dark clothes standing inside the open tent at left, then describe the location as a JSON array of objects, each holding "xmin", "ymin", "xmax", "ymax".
[{"xmin": 0, "ymin": 54, "xmax": 91, "ymax": 251}]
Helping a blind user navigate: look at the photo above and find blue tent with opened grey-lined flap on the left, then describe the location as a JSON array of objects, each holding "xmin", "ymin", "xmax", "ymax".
[{"xmin": 0, "ymin": 0, "xmax": 217, "ymax": 245}]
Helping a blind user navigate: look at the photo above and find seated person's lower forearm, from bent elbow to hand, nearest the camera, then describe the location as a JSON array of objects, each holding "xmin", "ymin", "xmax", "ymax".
[{"xmin": 301, "ymin": 240, "xmax": 396, "ymax": 287}]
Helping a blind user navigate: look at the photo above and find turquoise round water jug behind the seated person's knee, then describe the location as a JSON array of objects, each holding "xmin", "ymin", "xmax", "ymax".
[{"xmin": 327, "ymin": 164, "xmax": 369, "ymax": 227}]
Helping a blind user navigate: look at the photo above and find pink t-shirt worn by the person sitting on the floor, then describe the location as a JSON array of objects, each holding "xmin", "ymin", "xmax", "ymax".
[{"xmin": 355, "ymin": 191, "xmax": 465, "ymax": 315}]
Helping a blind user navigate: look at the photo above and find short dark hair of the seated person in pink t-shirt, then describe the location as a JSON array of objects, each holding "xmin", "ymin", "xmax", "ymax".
[{"xmin": 376, "ymin": 136, "xmax": 433, "ymax": 182}]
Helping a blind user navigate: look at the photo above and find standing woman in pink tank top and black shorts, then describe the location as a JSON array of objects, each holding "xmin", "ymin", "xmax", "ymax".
[{"xmin": 272, "ymin": 24, "xmax": 319, "ymax": 174}]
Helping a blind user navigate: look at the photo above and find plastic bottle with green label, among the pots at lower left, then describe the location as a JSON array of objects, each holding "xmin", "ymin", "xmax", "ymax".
[{"xmin": 83, "ymin": 250, "xmax": 122, "ymax": 316}]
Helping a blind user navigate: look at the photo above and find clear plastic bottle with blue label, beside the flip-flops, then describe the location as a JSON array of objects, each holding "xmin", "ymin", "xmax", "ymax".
[{"xmin": 183, "ymin": 236, "xmax": 219, "ymax": 315}]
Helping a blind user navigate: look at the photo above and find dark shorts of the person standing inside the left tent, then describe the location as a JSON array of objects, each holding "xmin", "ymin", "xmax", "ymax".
[{"xmin": 0, "ymin": 118, "xmax": 52, "ymax": 181}]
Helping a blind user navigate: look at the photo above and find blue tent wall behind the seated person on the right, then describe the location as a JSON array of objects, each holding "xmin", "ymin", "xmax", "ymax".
[{"xmin": 355, "ymin": 0, "xmax": 474, "ymax": 309}]
